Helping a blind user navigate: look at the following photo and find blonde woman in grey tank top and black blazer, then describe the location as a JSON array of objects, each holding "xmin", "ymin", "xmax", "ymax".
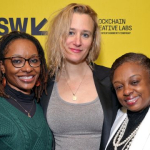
[{"xmin": 41, "ymin": 3, "xmax": 118, "ymax": 150}]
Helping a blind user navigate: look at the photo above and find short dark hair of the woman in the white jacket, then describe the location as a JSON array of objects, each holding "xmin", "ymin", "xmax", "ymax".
[{"xmin": 110, "ymin": 52, "xmax": 150, "ymax": 81}]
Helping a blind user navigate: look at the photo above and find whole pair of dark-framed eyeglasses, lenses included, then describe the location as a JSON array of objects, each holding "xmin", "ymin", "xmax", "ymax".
[{"xmin": 3, "ymin": 56, "xmax": 41, "ymax": 68}]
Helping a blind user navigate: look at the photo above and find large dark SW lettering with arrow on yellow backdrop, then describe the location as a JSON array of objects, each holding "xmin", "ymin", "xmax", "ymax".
[{"xmin": 0, "ymin": 18, "xmax": 47, "ymax": 36}]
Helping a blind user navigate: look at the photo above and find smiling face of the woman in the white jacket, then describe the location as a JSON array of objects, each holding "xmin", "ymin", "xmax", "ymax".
[{"xmin": 113, "ymin": 62, "xmax": 150, "ymax": 111}]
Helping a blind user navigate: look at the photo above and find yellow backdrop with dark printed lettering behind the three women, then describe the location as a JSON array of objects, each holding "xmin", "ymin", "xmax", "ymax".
[{"xmin": 0, "ymin": 0, "xmax": 150, "ymax": 67}]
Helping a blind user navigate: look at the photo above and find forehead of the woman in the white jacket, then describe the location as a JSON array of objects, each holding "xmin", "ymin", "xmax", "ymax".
[{"xmin": 113, "ymin": 62, "xmax": 149, "ymax": 81}]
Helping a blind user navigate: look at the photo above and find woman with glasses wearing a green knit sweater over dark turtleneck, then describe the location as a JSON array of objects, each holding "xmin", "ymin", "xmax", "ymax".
[{"xmin": 0, "ymin": 31, "xmax": 52, "ymax": 150}]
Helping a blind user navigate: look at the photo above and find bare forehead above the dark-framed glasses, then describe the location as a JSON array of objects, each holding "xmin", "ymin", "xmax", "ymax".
[{"xmin": 6, "ymin": 39, "xmax": 38, "ymax": 55}]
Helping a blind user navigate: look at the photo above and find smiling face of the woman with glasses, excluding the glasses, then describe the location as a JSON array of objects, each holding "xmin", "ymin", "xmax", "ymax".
[{"xmin": 1, "ymin": 39, "xmax": 40, "ymax": 94}]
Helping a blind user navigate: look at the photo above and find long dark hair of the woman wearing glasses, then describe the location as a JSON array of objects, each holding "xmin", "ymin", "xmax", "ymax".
[{"xmin": 0, "ymin": 31, "xmax": 47, "ymax": 100}]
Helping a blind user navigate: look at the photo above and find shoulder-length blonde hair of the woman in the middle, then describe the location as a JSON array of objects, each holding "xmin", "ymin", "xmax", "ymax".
[{"xmin": 46, "ymin": 3, "xmax": 100, "ymax": 77}]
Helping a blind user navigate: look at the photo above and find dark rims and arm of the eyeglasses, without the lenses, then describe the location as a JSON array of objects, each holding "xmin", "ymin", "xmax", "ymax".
[{"xmin": 3, "ymin": 56, "xmax": 41, "ymax": 68}]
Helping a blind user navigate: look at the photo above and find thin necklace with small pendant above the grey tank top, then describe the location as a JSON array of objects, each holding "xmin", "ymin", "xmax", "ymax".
[{"xmin": 65, "ymin": 70, "xmax": 87, "ymax": 101}]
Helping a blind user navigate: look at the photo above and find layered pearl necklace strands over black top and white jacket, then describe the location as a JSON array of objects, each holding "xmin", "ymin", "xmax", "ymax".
[{"xmin": 113, "ymin": 117, "xmax": 140, "ymax": 150}]
